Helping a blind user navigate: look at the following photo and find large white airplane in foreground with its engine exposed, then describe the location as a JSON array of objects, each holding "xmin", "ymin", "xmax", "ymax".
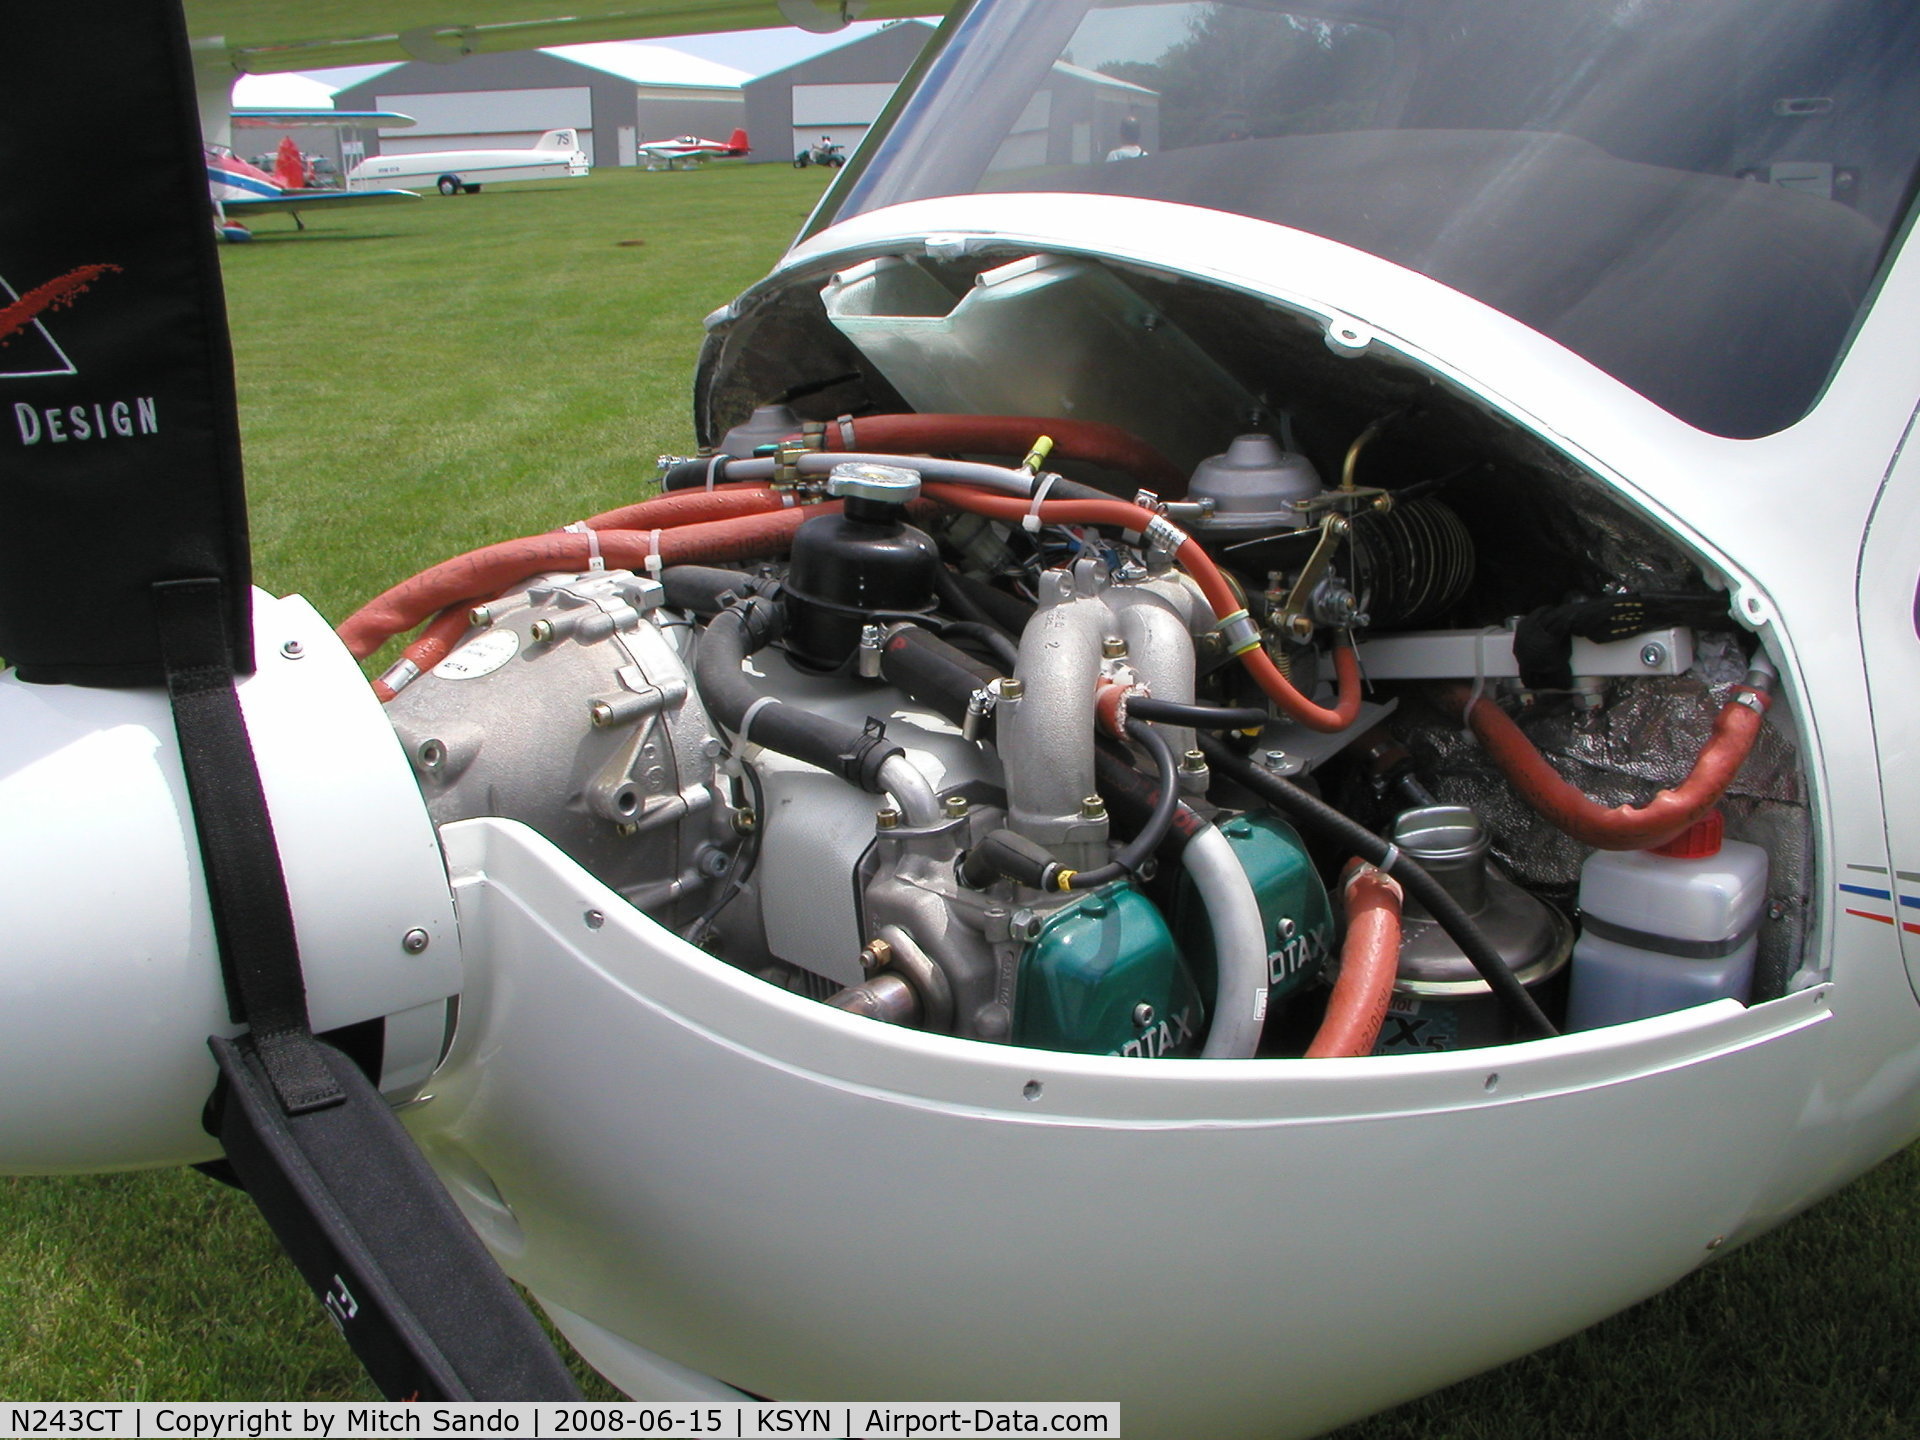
[{"xmin": 11, "ymin": 0, "xmax": 1920, "ymax": 1440}]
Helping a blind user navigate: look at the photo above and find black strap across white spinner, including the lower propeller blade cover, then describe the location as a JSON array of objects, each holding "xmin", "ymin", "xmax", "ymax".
[{"xmin": 154, "ymin": 580, "xmax": 580, "ymax": 1400}]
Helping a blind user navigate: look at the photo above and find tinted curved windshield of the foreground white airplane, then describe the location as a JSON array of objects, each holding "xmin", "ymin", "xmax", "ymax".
[{"xmin": 822, "ymin": 0, "xmax": 1920, "ymax": 436}]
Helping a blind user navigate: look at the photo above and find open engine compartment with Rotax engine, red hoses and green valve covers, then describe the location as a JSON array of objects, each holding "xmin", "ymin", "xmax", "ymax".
[{"xmin": 353, "ymin": 252, "xmax": 1820, "ymax": 1060}]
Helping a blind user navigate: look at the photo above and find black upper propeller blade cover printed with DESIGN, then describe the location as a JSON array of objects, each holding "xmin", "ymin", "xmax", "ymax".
[{"xmin": 0, "ymin": 0, "xmax": 253, "ymax": 685}]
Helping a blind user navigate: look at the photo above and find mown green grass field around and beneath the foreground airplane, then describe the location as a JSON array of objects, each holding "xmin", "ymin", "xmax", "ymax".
[{"xmin": 0, "ymin": 165, "xmax": 1920, "ymax": 1440}]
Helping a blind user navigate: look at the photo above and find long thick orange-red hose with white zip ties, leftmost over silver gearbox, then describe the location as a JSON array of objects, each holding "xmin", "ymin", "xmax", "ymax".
[{"xmin": 340, "ymin": 505, "xmax": 821, "ymax": 660}]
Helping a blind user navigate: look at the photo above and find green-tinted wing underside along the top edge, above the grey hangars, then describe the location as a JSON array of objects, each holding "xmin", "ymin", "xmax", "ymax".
[{"xmin": 186, "ymin": 0, "xmax": 952, "ymax": 75}]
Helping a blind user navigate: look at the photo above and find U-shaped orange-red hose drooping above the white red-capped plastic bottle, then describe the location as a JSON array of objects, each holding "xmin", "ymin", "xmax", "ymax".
[{"xmin": 1442, "ymin": 676, "xmax": 1772, "ymax": 851}]
